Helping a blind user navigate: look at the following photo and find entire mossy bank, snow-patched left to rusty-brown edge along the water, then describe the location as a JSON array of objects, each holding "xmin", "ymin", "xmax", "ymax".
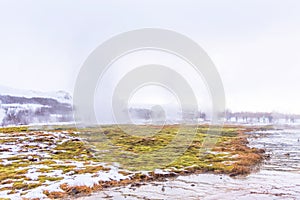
[{"xmin": 0, "ymin": 125, "xmax": 264, "ymax": 199}]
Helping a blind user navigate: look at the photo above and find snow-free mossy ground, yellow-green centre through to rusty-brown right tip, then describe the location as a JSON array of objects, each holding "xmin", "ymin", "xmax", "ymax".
[{"xmin": 82, "ymin": 125, "xmax": 262, "ymax": 175}]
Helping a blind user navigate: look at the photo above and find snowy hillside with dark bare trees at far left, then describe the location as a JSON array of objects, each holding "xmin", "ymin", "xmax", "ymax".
[{"xmin": 0, "ymin": 86, "xmax": 73, "ymax": 126}]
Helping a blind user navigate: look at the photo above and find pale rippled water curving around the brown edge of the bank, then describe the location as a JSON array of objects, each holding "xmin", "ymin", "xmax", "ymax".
[{"xmin": 82, "ymin": 130, "xmax": 300, "ymax": 200}]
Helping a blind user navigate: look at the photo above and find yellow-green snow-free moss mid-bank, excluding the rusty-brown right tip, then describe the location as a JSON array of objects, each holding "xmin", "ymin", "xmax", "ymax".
[{"xmin": 74, "ymin": 125, "xmax": 247, "ymax": 170}]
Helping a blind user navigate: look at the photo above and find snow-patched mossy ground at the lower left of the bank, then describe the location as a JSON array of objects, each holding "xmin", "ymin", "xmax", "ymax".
[{"xmin": 0, "ymin": 131, "xmax": 139, "ymax": 200}]
